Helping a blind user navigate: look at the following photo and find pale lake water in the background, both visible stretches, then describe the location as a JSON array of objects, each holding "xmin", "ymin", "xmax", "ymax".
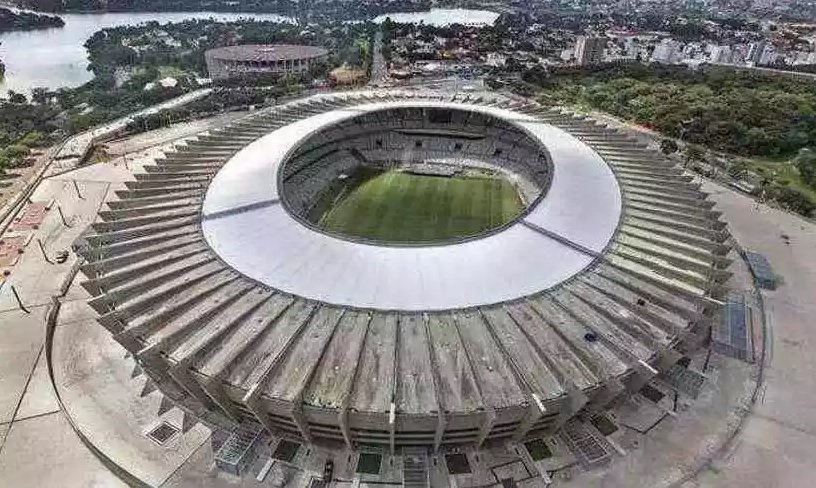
[{"xmin": 0, "ymin": 9, "xmax": 498, "ymax": 94}]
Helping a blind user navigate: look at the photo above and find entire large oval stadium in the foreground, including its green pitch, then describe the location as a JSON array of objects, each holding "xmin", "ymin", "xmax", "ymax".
[{"xmin": 76, "ymin": 91, "xmax": 729, "ymax": 476}]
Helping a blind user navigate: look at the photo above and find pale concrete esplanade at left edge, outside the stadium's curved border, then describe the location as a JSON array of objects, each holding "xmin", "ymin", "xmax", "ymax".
[{"xmin": 0, "ymin": 166, "xmax": 125, "ymax": 488}]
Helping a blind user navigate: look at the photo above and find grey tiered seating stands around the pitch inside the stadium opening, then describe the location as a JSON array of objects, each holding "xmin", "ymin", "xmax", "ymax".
[{"xmin": 283, "ymin": 105, "xmax": 551, "ymax": 214}]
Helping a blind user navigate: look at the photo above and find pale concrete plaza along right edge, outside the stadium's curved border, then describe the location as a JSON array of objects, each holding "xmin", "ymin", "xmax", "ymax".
[{"xmin": 699, "ymin": 184, "xmax": 816, "ymax": 488}]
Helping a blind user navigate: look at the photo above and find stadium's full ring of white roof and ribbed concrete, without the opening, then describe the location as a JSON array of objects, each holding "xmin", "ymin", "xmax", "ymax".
[{"xmin": 81, "ymin": 91, "xmax": 728, "ymax": 448}]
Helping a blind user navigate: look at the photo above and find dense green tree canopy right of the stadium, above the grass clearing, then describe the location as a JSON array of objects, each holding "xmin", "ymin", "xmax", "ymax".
[{"xmin": 522, "ymin": 63, "xmax": 816, "ymax": 157}]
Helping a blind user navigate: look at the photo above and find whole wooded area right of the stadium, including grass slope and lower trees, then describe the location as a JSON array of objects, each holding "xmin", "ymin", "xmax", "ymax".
[{"xmin": 515, "ymin": 63, "xmax": 816, "ymax": 215}]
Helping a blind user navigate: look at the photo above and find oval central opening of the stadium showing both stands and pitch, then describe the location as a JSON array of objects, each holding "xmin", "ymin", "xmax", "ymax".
[{"xmin": 278, "ymin": 106, "xmax": 553, "ymax": 246}]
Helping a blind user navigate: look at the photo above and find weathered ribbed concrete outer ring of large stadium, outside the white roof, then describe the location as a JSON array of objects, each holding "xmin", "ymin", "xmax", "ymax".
[{"xmin": 75, "ymin": 92, "xmax": 729, "ymax": 460}]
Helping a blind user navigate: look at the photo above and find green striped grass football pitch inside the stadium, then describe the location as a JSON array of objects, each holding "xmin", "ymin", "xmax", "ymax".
[{"xmin": 319, "ymin": 171, "xmax": 522, "ymax": 243}]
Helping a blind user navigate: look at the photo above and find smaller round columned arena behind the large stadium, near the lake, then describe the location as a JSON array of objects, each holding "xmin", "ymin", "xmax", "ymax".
[{"xmin": 204, "ymin": 44, "xmax": 329, "ymax": 80}]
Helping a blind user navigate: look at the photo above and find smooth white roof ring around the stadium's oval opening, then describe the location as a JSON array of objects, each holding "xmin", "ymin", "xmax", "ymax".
[{"xmin": 202, "ymin": 101, "xmax": 621, "ymax": 311}]
